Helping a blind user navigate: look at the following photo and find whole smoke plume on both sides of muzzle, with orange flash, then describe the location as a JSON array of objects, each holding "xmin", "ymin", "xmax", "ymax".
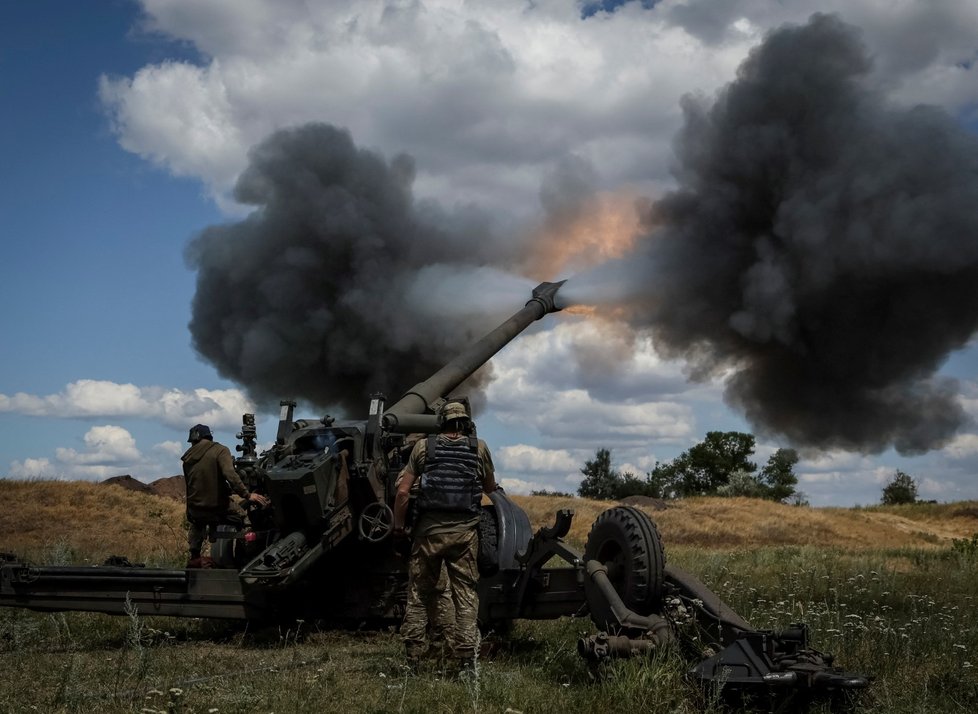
[{"xmin": 188, "ymin": 15, "xmax": 978, "ymax": 453}]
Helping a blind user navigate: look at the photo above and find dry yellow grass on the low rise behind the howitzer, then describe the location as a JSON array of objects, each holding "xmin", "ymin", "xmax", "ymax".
[{"xmin": 0, "ymin": 479, "xmax": 978, "ymax": 562}]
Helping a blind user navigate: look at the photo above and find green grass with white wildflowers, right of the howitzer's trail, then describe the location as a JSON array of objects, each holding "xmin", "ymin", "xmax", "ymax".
[{"xmin": 677, "ymin": 548, "xmax": 978, "ymax": 712}]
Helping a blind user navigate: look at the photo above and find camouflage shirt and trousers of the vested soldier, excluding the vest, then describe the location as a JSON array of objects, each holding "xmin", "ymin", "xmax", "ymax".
[{"xmin": 403, "ymin": 434, "xmax": 496, "ymax": 660}]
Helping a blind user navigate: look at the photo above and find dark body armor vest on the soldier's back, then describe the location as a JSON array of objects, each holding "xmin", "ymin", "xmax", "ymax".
[{"xmin": 418, "ymin": 436, "xmax": 482, "ymax": 514}]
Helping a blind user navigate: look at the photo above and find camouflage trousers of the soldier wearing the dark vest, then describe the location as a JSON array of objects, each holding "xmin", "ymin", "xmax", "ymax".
[{"xmin": 401, "ymin": 530, "xmax": 479, "ymax": 659}]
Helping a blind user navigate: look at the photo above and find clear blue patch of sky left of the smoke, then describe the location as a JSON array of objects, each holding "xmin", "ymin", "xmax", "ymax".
[{"xmin": 0, "ymin": 0, "xmax": 222, "ymax": 470}]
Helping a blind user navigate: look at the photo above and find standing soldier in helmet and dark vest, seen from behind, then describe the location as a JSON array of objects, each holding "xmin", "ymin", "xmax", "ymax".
[{"xmin": 394, "ymin": 402, "xmax": 496, "ymax": 668}]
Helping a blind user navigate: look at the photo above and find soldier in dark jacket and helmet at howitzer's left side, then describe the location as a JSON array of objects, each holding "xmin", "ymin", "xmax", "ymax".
[{"xmin": 181, "ymin": 424, "xmax": 268, "ymax": 568}]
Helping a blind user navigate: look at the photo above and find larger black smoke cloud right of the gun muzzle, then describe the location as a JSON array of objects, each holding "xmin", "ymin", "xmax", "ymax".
[{"xmin": 568, "ymin": 15, "xmax": 978, "ymax": 453}]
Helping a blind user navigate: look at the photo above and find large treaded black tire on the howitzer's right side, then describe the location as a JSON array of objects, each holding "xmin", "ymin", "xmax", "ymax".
[{"xmin": 584, "ymin": 506, "xmax": 666, "ymax": 631}]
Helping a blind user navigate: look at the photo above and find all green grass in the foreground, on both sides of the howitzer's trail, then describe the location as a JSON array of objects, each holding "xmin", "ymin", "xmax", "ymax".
[{"xmin": 0, "ymin": 547, "xmax": 978, "ymax": 714}]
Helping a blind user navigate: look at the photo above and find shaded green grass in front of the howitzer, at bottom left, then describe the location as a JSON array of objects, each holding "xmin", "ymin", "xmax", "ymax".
[{"xmin": 0, "ymin": 610, "xmax": 703, "ymax": 714}]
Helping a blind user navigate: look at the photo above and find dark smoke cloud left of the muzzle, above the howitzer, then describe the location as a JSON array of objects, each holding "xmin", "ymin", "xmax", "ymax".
[{"xmin": 187, "ymin": 124, "xmax": 532, "ymax": 416}]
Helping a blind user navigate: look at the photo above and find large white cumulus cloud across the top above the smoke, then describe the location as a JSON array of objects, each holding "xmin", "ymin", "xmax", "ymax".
[{"xmin": 100, "ymin": 0, "xmax": 978, "ymax": 212}]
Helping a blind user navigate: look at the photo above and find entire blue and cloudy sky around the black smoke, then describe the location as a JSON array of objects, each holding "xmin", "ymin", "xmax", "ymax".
[{"xmin": 0, "ymin": 0, "xmax": 978, "ymax": 505}]
